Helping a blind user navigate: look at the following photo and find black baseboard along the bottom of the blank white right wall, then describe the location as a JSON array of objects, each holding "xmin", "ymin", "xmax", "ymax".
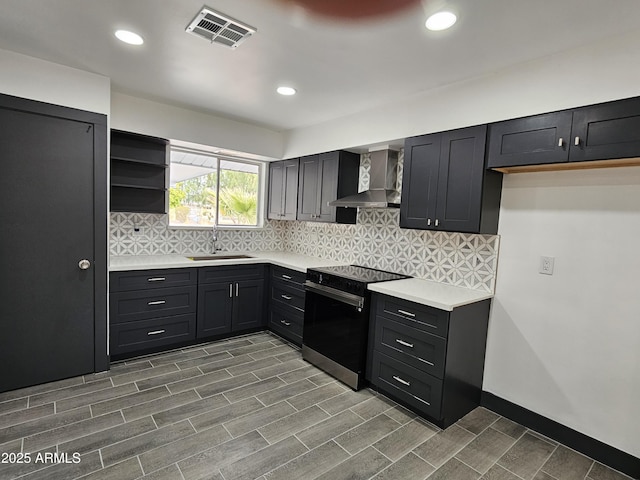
[{"xmin": 480, "ymin": 391, "xmax": 640, "ymax": 479}]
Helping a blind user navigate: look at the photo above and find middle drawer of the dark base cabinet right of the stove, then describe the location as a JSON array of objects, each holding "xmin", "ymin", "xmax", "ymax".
[{"xmin": 374, "ymin": 316, "xmax": 446, "ymax": 378}]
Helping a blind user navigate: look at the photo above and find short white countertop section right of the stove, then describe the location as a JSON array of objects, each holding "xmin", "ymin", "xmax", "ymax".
[{"xmin": 368, "ymin": 278, "xmax": 493, "ymax": 312}]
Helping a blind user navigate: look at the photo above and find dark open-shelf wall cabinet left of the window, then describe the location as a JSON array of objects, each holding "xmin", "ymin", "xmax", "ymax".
[{"xmin": 111, "ymin": 130, "xmax": 169, "ymax": 213}]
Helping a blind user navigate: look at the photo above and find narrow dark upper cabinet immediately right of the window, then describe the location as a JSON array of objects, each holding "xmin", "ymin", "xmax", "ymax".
[{"xmin": 267, "ymin": 158, "xmax": 300, "ymax": 220}]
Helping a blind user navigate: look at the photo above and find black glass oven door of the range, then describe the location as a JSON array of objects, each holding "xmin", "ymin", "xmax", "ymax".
[{"xmin": 302, "ymin": 281, "xmax": 369, "ymax": 378}]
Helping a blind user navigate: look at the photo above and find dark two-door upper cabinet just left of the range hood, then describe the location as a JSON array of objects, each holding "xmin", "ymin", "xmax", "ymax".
[{"xmin": 297, "ymin": 151, "xmax": 360, "ymax": 223}]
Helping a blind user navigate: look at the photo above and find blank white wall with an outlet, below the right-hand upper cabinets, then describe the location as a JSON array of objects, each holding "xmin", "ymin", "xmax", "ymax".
[{"xmin": 484, "ymin": 167, "xmax": 640, "ymax": 457}]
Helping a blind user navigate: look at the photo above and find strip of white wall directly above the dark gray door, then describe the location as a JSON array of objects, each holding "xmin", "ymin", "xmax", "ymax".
[{"xmin": 0, "ymin": 49, "xmax": 111, "ymax": 115}]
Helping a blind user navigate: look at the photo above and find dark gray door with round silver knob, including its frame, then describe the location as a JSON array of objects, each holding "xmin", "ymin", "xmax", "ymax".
[{"xmin": 0, "ymin": 94, "xmax": 106, "ymax": 391}]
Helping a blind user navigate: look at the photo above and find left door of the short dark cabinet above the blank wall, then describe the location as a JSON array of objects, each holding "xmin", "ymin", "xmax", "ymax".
[{"xmin": 487, "ymin": 111, "xmax": 572, "ymax": 168}]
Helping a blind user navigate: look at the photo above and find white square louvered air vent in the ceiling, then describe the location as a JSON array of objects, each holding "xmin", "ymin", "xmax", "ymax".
[{"xmin": 187, "ymin": 7, "xmax": 256, "ymax": 48}]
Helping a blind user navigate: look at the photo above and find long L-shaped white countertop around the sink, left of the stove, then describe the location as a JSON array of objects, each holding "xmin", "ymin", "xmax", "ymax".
[{"xmin": 109, "ymin": 251, "xmax": 344, "ymax": 273}]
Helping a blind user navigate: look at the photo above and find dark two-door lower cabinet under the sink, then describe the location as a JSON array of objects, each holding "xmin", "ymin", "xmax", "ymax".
[{"xmin": 197, "ymin": 265, "xmax": 265, "ymax": 338}]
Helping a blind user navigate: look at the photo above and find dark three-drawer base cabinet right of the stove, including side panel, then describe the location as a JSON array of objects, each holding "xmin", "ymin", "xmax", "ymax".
[{"xmin": 367, "ymin": 294, "xmax": 491, "ymax": 428}]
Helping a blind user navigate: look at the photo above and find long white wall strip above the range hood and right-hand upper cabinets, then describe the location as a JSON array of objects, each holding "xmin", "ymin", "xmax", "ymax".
[{"xmin": 284, "ymin": 32, "xmax": 640, "ymax": 158}]
